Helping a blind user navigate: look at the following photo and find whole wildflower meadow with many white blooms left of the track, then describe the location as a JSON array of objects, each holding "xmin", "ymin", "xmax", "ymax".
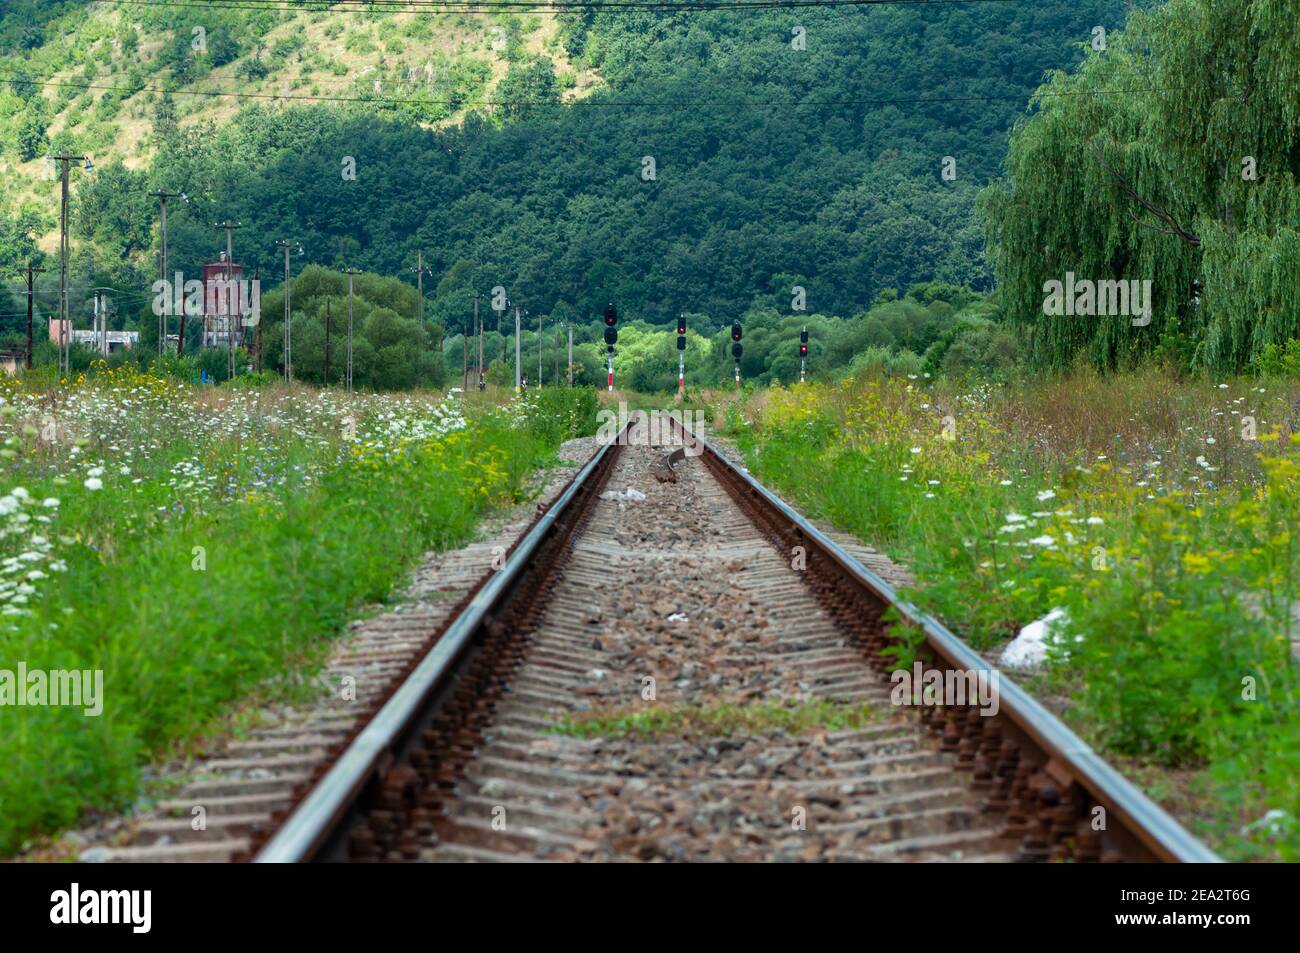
[{"xmin": 0, "ymin": 369, "xmax": 595, "ymax": 853}]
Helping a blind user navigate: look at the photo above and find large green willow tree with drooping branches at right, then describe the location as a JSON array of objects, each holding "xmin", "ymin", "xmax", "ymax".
[{"xmin": 979, "ymin": 0, "xmax": 1300, "ymax": 371}]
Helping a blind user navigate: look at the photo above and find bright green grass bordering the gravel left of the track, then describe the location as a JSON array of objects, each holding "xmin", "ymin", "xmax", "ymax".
[{"xmin": 0, "ymin": 369, "xmax": 594, "ymax": 853}]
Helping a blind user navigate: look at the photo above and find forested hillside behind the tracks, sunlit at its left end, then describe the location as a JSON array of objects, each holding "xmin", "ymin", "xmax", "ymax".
[{"xmin": 0, "ymin": 0, "xmax": 1125, "ymax": 343}]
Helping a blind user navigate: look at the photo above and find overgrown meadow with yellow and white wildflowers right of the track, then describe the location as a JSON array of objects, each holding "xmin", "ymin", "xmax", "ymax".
[{"xmin": 728, "ymin": 371, "xmax": 1300, "ymax": 861}]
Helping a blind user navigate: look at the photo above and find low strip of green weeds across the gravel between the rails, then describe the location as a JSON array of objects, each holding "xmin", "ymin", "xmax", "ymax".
[{"xmin": 553, "ymin": 701, "xmax": 879, "ymax": 738}]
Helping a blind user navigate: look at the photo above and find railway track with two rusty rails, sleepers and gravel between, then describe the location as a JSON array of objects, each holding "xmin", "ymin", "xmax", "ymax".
[{"xmin": 241, "ymin": 421, "xmax": 1217, "ymax": 862}]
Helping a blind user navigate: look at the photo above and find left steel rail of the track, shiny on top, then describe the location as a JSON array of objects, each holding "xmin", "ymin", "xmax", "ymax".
[{"xmin": 252, "ymin": 426, "xmax": 614, "ymax": 863}]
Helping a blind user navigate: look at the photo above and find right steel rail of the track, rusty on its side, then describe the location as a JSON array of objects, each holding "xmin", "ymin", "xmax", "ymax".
[{"xmin": 684, "ymin": 428, "xmax": 1222, "ymax": 863}]
